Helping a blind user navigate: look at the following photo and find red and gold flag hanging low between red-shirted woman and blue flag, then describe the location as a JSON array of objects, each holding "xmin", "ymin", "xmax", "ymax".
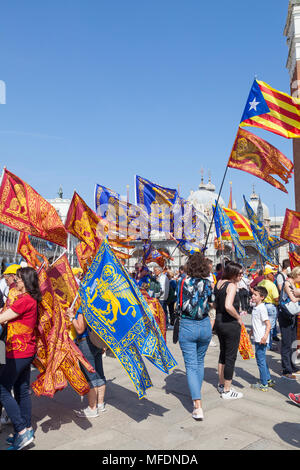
[{"xmin": 31, "ymin": 268, "xmax": 94, "ymax": 398}]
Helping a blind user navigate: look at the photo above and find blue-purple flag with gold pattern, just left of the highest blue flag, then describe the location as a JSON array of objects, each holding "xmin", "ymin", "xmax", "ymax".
[{"xmin": 95, "ymin": 184, "xmax": 148, "ymax": 240}]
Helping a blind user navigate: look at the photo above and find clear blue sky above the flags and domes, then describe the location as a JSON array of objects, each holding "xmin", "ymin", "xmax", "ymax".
[{"xmin": 0, "ymin": 0, "xmax": 294, "ymax": 216}]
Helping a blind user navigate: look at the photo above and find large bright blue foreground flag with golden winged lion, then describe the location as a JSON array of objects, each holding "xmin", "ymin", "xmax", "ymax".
[{"xmin": 79, "ymin": 239, "xmax": 177, "ymax": 398}]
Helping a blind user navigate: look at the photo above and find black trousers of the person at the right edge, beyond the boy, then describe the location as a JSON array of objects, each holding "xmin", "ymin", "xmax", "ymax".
[{"xmin": 278, "ymin": 314, "xmax": 298, "ymax": 374}]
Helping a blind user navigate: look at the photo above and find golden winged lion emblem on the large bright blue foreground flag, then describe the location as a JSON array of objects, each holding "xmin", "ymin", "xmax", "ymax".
[{"xmin": 87, "ymin": 264, "xmax": 139, "ymax": 332}]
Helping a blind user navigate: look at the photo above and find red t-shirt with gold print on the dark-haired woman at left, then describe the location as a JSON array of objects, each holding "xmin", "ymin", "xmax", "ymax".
[{"xmin": 6, "ymin": 293, "xmax": 37, "ymax": 359}]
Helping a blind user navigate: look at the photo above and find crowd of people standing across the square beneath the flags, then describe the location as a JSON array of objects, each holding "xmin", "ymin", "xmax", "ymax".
[{"xmin": 0, "ymin": 252, "xmax": 300, "ymax": 450}]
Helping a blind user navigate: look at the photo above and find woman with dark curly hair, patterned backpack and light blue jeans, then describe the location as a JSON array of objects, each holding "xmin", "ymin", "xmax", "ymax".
[{"xmin": 177, "ymin": 252, "xmax": 212, "ymax": 420}]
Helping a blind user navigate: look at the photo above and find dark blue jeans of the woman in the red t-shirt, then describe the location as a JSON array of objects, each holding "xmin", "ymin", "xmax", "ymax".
[{"xmin": 0, "ymin": 357, "xmax": 34, "ymax": 432}]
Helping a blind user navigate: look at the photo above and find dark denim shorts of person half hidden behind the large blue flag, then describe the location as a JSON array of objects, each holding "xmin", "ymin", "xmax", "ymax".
[{"xmin": 77, "ymin": 337, "xmax": 106, "ymax": 388}]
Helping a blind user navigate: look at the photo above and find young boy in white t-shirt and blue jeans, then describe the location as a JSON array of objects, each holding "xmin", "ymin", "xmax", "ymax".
[{"xmin": 251, "ymin": 286, "xmax": 274, "ymax": 392}]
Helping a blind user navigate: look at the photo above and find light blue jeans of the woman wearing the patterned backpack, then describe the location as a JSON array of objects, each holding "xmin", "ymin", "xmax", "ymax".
[{"xmin": 179, "ymin": 316, "xmax": 212, "ymax": 400}]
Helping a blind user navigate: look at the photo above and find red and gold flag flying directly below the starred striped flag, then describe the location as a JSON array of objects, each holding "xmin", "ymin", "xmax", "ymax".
[{"xmin": 227, "ymin": 129, "xmax": 292, "ymax": 193}]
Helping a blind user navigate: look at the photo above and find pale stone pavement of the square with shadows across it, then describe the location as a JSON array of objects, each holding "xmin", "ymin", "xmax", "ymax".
[{"xmin": 0, "ymin": 316, "xmax": 300, "ymax": 451}]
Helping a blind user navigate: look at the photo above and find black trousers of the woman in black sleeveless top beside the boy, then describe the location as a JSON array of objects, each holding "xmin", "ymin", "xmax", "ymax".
[{"xmin": 215, "ymin": 314, "xmax": 241, "ymax": 380}]
